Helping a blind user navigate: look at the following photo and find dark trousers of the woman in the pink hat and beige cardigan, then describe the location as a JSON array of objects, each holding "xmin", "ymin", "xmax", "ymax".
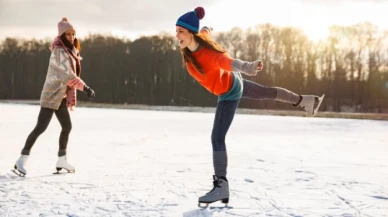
[{"xmin": 21, "ymin": 99, "xmax": 71, "ymax": 157}]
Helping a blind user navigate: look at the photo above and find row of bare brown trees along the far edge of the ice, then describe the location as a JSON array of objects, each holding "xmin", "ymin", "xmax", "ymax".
[{"xmin": 0, "ymin": 23, "xmax": 388, "ymax": 112}]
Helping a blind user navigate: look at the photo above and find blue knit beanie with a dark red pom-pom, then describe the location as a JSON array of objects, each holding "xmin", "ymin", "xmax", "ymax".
[{"xmin": 176, "ymin": 7, "xmax": 205, "ymax": 33}]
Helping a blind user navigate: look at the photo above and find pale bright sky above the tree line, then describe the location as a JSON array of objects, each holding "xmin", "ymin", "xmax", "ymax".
[{"xmin": 0, "ymin": 0, "xmax": 388, "ymax": 40}]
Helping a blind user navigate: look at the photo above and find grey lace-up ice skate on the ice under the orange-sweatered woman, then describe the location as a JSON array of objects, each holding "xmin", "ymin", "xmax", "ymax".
[{"xmin": 198, "ymin": 175, "xmax": 229, "ymax": 208}]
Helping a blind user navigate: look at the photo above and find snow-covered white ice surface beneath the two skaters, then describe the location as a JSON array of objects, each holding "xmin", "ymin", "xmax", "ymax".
[{"xmin": 0, "ymin": 104, "xmax": 388, "ymax": 217}]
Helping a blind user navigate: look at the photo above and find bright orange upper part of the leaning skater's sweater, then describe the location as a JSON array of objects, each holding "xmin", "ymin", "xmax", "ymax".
[{"xmin": 186, "ymin": 47, "xmax": 233, "ymax": 96}]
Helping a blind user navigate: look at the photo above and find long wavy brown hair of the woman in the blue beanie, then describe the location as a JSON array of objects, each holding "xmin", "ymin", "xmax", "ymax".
[{"xmin": 181, "ymin": 30, "xmax": 227, "ymax": 73}]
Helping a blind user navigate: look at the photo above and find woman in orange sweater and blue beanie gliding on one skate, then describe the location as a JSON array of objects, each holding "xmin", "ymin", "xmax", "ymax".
[{"xmin": 176, "ymin": 7, "xmax": 324, "ymax": 205}]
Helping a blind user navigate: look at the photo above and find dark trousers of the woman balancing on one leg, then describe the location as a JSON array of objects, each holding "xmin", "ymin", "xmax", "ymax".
[{"xmin": 211, "ymin": 79, "xmax": 288, "ymax": 177}]
